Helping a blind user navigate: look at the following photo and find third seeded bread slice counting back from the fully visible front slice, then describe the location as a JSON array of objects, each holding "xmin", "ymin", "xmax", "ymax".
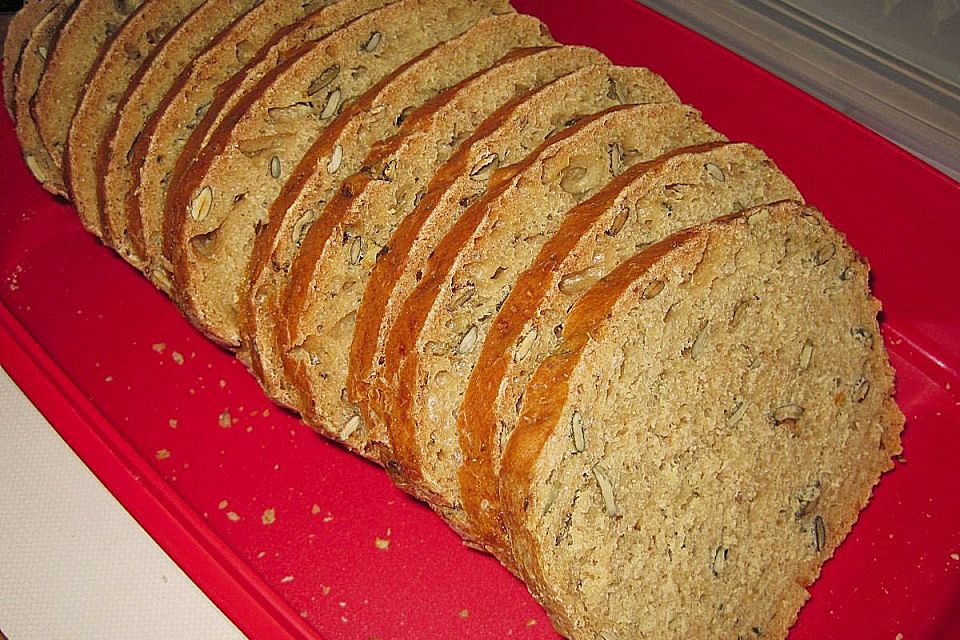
[{"xmin": 374, "ymin": 104, "xmax": 722, "ymax": 537}]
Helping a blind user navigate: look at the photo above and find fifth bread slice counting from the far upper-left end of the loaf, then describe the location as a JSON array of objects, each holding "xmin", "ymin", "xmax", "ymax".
[{"xmin": 93, "ymin": 0, "xmax": 259, "ymax": 269}]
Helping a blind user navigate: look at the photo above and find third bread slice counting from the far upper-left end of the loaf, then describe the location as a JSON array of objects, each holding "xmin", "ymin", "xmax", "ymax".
[{"xmin": 30, "ymin": 0, "xmax": 143, "ymax": 176}]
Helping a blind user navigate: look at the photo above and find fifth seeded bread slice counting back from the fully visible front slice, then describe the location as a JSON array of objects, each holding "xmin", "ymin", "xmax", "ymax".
[{"xmin": 278, "ymin": 47, "xmax": 605, "ymax": 456}]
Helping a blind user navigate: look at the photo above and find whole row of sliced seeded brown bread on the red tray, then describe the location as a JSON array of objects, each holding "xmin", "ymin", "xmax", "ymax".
[{"xmin": 4, "ymin": 0, "xmax": 903, "ymax": 640}]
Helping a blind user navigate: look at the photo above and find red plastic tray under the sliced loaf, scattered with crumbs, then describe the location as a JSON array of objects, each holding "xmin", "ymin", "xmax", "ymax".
[{"xmin": 0, "ymin": 0, "xmax": 960, "ymax": 640}]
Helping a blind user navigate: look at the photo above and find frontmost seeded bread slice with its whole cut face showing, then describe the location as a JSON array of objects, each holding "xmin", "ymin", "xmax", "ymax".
[{"xmin": 500, "ymin": 202, "xmax": 903, "ymax": 640}]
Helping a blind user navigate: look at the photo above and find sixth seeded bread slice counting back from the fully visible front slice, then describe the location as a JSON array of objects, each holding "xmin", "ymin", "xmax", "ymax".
[{"xmin": 239, "ymin": 13, "xmax": 553, "ymax": 406}]
